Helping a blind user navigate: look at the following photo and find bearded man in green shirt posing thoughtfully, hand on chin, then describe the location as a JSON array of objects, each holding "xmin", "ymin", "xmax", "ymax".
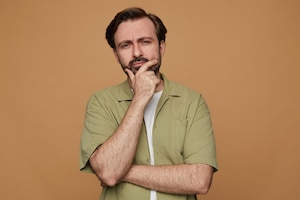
[{"xmin": 80, "ymin": 8, "xmax": 217, "ymax": 200}]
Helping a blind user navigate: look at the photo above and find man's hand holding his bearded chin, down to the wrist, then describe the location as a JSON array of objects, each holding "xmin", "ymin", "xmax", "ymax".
[{"xmin": 125, "ymin": 60, "xmax": 161, "ymax": 103}]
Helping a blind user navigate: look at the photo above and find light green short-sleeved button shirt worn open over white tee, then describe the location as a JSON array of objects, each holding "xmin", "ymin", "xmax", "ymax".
[{"xmin": 80, "ymin": 75, "xmax": 217, "ymax": 200}]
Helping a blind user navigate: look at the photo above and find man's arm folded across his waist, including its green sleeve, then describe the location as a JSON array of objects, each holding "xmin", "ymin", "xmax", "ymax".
[{"xmin": 123, "ymin": 96, "xmax": 217, "ymax": 194}]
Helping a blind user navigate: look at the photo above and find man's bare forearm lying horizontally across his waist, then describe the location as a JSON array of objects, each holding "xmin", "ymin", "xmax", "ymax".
[{"xmin": 123, "ymin": 164, "xmax": 213, "ymax": 194}]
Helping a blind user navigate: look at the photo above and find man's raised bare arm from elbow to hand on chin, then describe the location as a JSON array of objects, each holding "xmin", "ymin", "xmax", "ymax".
[{"xmin": 89, "ymin": 62, "xmax": 160, "ymax": 186}]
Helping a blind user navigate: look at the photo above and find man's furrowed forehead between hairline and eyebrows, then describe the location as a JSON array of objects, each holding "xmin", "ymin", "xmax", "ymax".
[{"xmin": 114, "ymin": 17, "xmax": 156, "ymax": 44}]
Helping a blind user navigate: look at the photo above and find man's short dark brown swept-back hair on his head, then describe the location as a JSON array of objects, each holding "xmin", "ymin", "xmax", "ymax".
[{"xmin": 105, "ymin": 7, "xmax": 167, "ymax": 49}]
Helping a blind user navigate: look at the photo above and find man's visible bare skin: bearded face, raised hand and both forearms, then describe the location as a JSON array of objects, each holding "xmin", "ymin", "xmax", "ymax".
[{"xmin": 90, "ymin": 18, "xmax": 213, "ymax": 194}]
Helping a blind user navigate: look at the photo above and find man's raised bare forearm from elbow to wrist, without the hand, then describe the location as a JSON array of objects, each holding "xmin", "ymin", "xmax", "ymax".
[{"xmin": 90, "ymin": 101, "xmax": 144, "ymax": 186}]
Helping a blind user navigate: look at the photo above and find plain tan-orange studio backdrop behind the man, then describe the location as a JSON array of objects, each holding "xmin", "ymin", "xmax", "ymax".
[{"xmin": 0, "ymin": 0, "xmax": 300, "ymax": 200}]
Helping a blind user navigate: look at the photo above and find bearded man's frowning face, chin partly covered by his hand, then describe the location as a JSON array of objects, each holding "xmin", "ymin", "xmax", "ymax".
[{"xmin": 114, "ymin": 18, "xmax": 165, "ymax": 74}]
